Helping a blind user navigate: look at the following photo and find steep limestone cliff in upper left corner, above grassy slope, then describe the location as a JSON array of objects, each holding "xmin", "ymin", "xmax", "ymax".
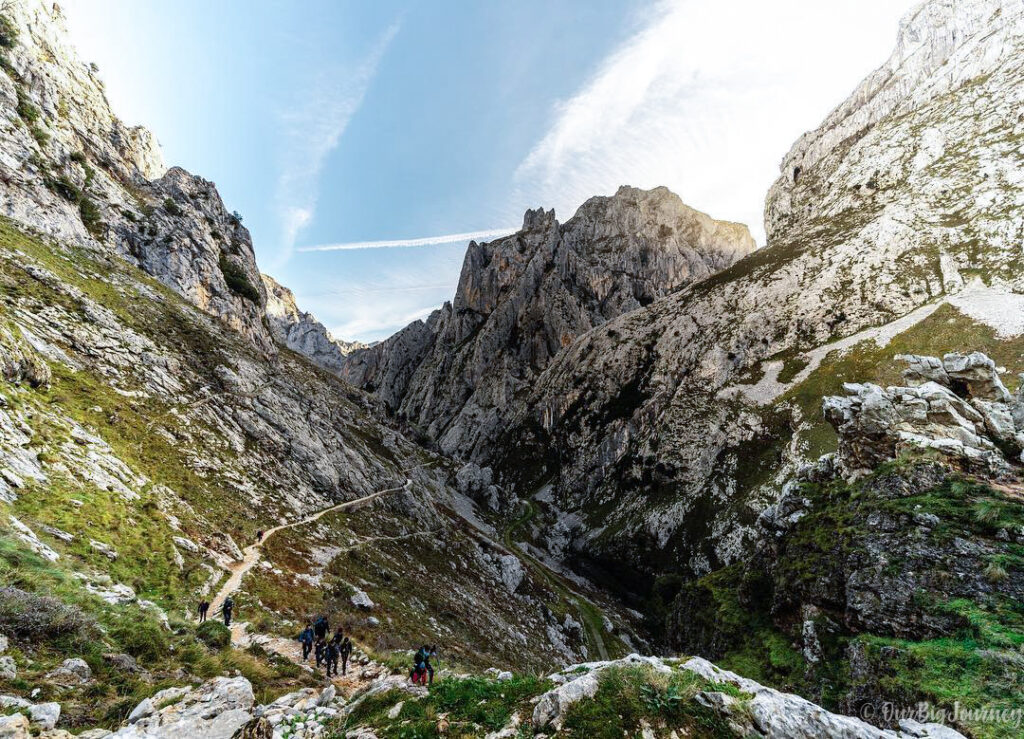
[{"xmin": 0, "ymin": 0, "xmax": 274, "ymax": 353}]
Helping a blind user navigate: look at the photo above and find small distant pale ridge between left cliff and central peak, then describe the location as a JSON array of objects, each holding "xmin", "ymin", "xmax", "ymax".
[{"xmin": 261, "ymin": 274, "xmax": 366, "ymax": 374}]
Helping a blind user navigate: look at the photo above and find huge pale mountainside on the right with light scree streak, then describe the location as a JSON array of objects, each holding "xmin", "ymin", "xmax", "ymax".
[{"xmin": 482, "ymin": 1, "xmax": 1024, "ymax": 595}]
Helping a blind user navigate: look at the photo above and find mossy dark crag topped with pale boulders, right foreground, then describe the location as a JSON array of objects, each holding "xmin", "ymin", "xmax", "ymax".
[{"xmin": 670, "ymin": 353, "xmax": 1024, "ymax": 736}]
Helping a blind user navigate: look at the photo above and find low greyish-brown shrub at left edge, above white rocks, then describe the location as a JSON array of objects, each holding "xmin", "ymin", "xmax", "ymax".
[{"xmin": 0, "ymin": 588, "xmax": 97, "ymax": 643}]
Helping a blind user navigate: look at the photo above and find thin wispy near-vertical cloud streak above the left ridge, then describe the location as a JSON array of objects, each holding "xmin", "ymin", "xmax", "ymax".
[{"xmin": 275, "ymin": 23, "xmax": 399, "ymax": 265}]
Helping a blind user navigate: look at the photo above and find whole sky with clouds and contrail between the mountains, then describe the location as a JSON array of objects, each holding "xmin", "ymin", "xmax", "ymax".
[{"xmin": 62, "ymin": 0, "xmax": 911, "ymax": 340}]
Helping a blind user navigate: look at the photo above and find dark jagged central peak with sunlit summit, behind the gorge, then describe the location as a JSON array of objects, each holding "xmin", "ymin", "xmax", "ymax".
[{"xmin": 342, "ymin": 187, "xmax": 755, "ymax": 459}]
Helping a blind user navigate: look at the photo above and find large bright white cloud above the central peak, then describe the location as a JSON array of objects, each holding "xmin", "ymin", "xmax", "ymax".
[{"xmin": 515, "ymin": 0, "xmax": 913, "ymax": 243}]
